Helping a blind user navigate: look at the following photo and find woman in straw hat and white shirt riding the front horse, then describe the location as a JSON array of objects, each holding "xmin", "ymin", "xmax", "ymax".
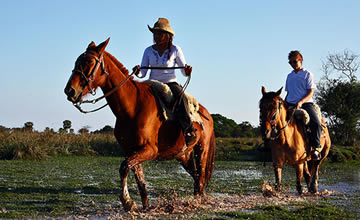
[{"xmin": 133, "ymin": 18, "xmax": 196, "ymax": 145}]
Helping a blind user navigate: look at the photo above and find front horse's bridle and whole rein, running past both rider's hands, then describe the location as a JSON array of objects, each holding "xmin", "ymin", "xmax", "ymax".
[{"xmin": 72, "ymin": 52, "xmax": 191, "ymax": 114}]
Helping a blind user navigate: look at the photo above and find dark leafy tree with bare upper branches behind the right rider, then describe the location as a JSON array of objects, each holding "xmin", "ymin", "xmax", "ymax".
[{"xmin": 315, "ymin": 50, "xmax": 360, "ymax": 145}]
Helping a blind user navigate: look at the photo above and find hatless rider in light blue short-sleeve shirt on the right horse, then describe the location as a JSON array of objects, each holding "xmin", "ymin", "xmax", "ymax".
[{"xmin": 285, "ymin": 50, "xmax": 322, "ymax": 160}]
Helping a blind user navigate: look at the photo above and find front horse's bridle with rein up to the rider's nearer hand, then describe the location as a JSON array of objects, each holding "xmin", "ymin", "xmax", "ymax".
[{"xmin": 72, "ymin": 52, "xmax": 135, "ymax": 114}]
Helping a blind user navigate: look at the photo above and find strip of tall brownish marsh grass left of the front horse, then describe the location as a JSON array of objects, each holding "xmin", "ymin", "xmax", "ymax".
[{"xmin": 0, "ymin": 132, "xmax": 122, "ymax": 160}]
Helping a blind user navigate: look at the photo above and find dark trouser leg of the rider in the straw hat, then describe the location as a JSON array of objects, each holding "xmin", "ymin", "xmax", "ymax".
[{"xmin": 166, "ymin": 82, "xmax": 193, "ymax": 134}]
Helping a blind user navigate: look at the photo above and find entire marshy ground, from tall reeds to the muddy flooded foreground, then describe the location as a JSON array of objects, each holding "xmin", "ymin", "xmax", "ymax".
[{"xmin": 0, "ymin": 132, "xmax": 360, "ymax": 219}]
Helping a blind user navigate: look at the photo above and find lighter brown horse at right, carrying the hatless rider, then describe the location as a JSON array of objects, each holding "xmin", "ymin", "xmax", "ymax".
[{"xmin": 259, "ymin": 87, "xmax": 331, "ymax": 194}]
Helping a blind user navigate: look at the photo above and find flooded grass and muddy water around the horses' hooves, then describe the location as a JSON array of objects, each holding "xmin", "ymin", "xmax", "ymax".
[{"xmin": 0, "ymin": 157, "xmax": 360, "ymax": 219}]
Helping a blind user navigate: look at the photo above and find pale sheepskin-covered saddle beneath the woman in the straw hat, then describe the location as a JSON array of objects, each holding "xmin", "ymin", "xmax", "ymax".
[{"xmin": 145, "ymin": 80, "xmax": 203, "ymax": 125}]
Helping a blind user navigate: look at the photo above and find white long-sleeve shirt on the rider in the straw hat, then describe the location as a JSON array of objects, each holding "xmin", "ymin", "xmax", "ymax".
[{"xmin": 138, "ymin": 44, "xmax": 186, "ymax": 83}]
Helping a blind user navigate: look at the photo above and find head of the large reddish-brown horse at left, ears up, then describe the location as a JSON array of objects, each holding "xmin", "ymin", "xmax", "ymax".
[{"xmin": 64, "ymin": 38, "xmax": 110, "ymax": 104}]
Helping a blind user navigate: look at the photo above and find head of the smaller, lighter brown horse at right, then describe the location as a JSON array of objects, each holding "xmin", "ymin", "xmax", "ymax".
[{"xmin": 259, "ymin": 87, "xmax": 283, "ymax": 139}]
